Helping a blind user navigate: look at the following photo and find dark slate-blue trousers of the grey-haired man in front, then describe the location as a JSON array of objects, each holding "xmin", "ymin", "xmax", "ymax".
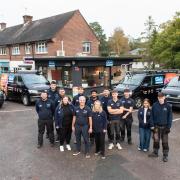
[{"xmin": 75, "ymin": 125, "xmax": 90, "ymax": 154}]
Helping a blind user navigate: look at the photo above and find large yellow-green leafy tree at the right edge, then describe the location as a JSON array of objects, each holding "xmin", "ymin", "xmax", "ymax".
[{"xmin": 151, "ymin": 12, "xmax": 180, "ymax": 68}]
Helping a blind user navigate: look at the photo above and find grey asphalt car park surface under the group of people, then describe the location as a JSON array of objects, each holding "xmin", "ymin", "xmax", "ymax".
[{"xmin": 0, "ymin": 101, "xmax": 180, "ymax": 180}]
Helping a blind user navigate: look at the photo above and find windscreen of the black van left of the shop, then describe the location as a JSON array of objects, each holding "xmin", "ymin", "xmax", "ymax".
[{"xmin": 22, "ymin": 74, "xmax": 48, "ymax": 84}]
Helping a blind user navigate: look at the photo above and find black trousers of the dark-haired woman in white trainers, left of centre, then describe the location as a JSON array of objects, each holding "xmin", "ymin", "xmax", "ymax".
[{"xmin": 59, "ymin": 125, "xmax": 72, "ymax": 146}]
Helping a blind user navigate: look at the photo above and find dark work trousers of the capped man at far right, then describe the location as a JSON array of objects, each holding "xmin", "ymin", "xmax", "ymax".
[{"xmin": 153, "ymin": 126, "xmax": 169, "ymax": 156}]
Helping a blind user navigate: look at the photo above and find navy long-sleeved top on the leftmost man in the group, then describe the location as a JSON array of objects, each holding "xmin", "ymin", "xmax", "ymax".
[{"xmin": 36, "ymin": 99, "xmax": 55, "ymax": 120}]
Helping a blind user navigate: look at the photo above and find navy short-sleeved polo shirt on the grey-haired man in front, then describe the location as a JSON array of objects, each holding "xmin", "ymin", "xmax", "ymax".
[{"xmin": 75, "ymin": 106, "xmax": 92, "ymax": 126}]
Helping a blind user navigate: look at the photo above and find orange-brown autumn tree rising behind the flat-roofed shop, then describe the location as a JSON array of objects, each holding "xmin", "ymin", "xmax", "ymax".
[{"xmin": 109, "ymin": 27, "xmax": 130, "ymax": 56}]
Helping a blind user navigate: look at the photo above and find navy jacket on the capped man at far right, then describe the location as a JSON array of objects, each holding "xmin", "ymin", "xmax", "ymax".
[{"xmin": 151, "ymin": 101, "xmax": 173, "ymax": 128}]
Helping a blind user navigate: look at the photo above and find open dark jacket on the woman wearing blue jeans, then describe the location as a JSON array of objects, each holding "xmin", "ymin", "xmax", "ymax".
[{"xmin": 138, "ymin": 107, "xmax": 151, "ymax": 128}]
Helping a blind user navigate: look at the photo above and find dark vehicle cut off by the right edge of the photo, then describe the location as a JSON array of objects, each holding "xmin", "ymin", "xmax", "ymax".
[{"xmin": 162, "ymin": 75, "xmax": 180, "ymax": 108}]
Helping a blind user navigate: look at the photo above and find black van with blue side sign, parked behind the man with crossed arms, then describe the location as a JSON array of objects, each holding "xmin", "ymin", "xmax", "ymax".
[{"xmin": 115, "ymin": 71, "xmax": 165, "ymax": 108}]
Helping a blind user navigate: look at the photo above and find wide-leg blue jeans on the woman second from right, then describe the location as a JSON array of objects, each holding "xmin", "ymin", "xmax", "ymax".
[{"xmin": 139, "ymin": 128, "xmax": 151, "ymax": 150}]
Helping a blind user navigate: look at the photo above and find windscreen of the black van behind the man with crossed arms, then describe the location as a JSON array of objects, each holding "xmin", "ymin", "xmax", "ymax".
[{"xmin": 121, "ymin": 74, "xmax": 144, "ymax": 86}]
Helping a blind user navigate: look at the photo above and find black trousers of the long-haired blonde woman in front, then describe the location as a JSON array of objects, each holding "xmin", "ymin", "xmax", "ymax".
[{"xmin": 94, "ymin": 132, "xmax": 105, "ymax": 156}]
